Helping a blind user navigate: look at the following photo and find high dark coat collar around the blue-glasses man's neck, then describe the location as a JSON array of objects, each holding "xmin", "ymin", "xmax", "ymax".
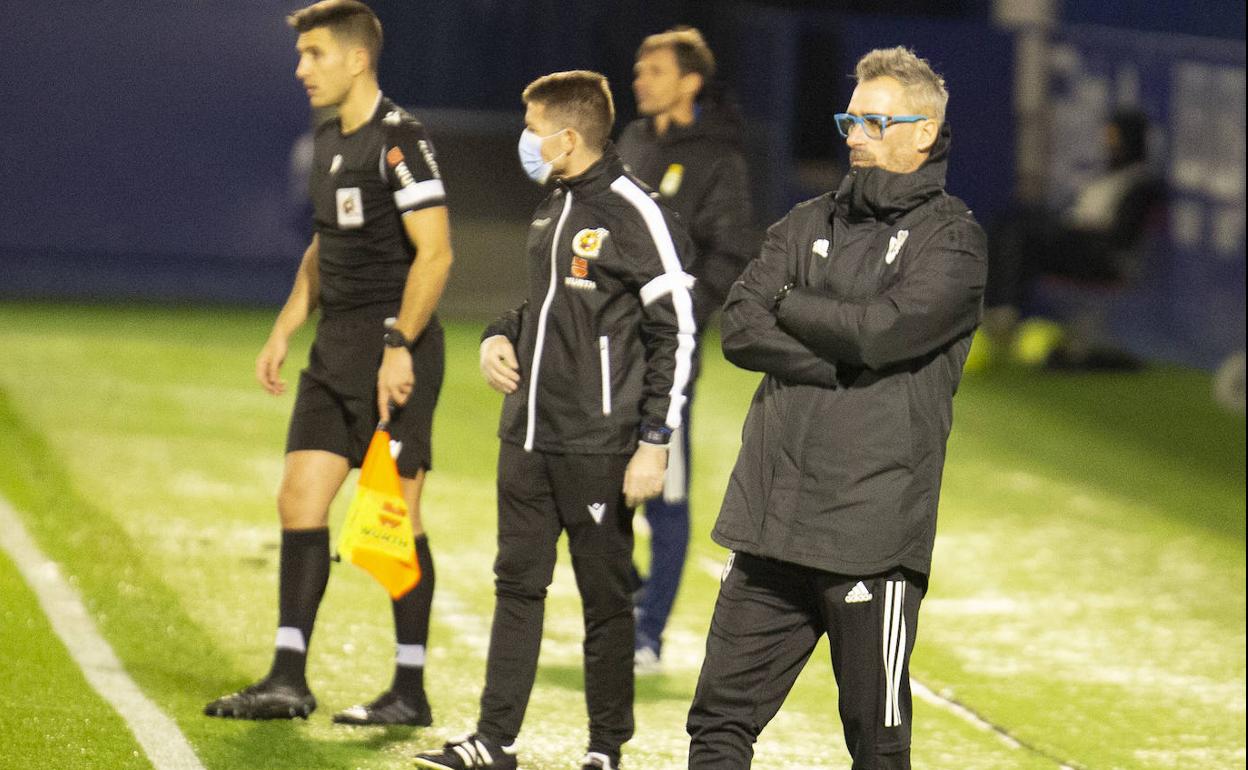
[{"xmin": 835, "ymin": 121, "xmax": 951, "ymax": 225}]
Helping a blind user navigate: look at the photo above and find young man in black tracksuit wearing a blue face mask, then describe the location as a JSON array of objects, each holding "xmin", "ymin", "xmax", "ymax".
[{"xmin": 416, "ymin": 71, "xmax": 695, "ymax": 770}]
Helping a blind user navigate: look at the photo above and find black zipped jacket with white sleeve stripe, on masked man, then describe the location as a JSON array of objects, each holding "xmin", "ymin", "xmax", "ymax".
[{"xmin": 483, "ymin": 147, "xmax": 695, "ymax": 454}]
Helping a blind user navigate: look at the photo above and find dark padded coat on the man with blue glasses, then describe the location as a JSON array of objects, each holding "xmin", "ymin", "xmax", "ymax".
[{"xmin": 713, "ymin": 122, "xmax": 987, "ymax": 575}]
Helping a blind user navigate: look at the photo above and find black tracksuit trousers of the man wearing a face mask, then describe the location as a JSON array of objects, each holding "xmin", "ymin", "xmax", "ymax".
[{"xmin": 477, "ymin": 442, "xmax": 636, "ymax": 760}]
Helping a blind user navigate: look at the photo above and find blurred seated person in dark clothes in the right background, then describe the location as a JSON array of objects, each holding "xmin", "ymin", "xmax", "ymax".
[{"xmin": 983, "ymin": 110, "xmax": 1166, "ymax": 364}]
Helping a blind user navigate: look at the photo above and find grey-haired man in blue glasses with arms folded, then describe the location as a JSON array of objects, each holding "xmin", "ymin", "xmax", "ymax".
[{"xmin": 688, "ymin": 49, "xmax": 987, "ymax": 770}]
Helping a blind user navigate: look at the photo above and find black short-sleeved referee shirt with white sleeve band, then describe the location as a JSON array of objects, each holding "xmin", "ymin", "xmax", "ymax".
[{"xmin": 310, "ymin": 95, "xmax": 447, "ymax": 316}]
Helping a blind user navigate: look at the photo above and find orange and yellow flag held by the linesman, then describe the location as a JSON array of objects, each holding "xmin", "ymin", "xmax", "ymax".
[{"xmin": 338, "ymin": 427, "xmax": 421, "ymax": 599}]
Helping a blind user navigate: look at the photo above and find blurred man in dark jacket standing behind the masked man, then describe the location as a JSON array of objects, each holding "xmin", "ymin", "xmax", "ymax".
[{"xmin": 619, "ymin": 27, "xmax": 755, "ymax": 673}]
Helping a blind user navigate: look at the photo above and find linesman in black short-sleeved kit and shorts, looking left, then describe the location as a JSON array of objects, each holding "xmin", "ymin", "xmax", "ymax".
[{"xmin": 205, "ymin": 0, "xmax": 452, "ymax": 725}]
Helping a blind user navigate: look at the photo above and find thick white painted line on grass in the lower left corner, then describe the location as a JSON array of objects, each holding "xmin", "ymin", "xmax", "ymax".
[{"xmin": 0, "ymin": 498, "xmax": 203, "ymax": 770}]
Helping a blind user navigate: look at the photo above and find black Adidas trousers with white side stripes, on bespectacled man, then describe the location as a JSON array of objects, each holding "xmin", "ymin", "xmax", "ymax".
[{"xmin": 686, "ymin": 553, "xmax": 926, "ymax": 770}]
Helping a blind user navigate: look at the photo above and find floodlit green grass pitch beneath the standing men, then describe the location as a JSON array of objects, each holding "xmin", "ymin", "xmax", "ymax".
[{"xmin": 0, "ymin": 305, "xmax": 1246, "ymax": 770}]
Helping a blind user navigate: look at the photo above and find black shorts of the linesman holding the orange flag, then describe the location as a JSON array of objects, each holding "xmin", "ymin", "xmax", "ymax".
[{"xmin": 286, "ymin": 316, "xmax": 446, "ymax": 478}]
